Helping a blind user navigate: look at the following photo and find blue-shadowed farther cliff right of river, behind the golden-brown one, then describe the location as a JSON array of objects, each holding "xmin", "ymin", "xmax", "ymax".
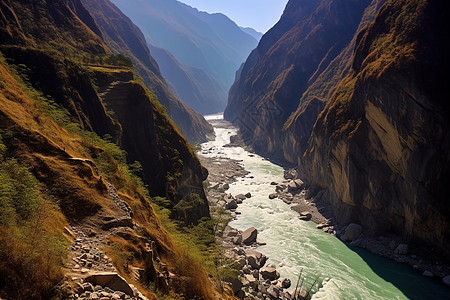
[{"xmin": 225, "ymin": 0, "xmax": 370, "ymax": 155}]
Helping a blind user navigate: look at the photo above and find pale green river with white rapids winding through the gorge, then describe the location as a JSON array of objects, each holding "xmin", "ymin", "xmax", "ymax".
[{"xmin": 202, "ymin": 114, "xmax": 450, "ymax": 300}]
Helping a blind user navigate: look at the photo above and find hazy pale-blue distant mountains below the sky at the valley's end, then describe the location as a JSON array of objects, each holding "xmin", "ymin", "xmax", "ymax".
[{"xmin": 112, "ymin": 0, "xmax": 258, "ymax": 114}]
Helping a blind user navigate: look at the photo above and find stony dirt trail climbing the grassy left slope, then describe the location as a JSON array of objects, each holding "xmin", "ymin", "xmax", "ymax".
[{"xmin": 58, "ymin": 183, "xmax": 147, "ymax": 300}]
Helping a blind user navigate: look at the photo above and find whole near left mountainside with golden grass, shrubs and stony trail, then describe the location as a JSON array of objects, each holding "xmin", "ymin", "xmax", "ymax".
[{"xmin": 0, "ymin": 0, "xmax": 232, "ymax": 299}]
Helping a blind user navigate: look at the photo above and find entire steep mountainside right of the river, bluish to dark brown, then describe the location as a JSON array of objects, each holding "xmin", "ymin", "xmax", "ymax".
[{"xmin": 225, "ymin": 0, "xmax": 450, "ymax": 258}]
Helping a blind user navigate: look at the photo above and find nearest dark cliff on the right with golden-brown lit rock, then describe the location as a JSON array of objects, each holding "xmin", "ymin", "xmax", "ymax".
[{"xmin": 301, "ymin": 1, "xmax": 450, "ymax": 255}]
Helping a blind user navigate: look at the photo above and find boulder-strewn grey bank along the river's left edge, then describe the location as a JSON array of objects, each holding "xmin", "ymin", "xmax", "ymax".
[{"xmin": 198, "ymin": 120, "xmax": 300, "ymax": 300}]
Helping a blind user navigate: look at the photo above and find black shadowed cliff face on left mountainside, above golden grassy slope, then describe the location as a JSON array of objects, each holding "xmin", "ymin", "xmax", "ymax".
[{"xmin": 92, "ymin": 68, "xmax": 209, "ymax": 212}]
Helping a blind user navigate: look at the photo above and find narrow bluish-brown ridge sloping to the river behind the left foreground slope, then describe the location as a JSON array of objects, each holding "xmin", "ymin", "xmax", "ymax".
[{"xmin": 83, "ymin": 0, "xmax": 214, "ymax": 143}]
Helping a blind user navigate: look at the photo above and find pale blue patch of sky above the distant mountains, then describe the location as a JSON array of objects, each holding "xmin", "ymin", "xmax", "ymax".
[{"xmin": 178, "ymin": 0, "xmax": 288, "ymax": 33}]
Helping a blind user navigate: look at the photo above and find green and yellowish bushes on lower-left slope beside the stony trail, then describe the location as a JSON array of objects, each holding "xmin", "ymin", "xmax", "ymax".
[{"xmin": 0, "ymin": 136, "xmax": 68, "ymax": 299}]
